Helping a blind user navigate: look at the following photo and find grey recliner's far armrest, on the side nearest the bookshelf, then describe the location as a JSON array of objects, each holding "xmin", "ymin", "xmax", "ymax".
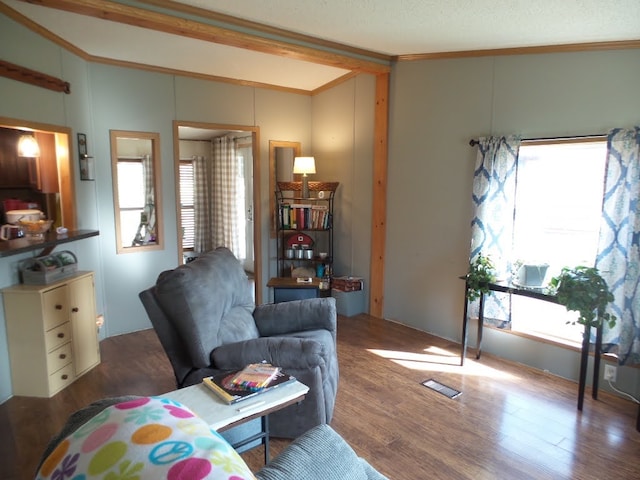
[{"xmin": 253, "ymin": 297, "xmax": 338, "ymax": 340}]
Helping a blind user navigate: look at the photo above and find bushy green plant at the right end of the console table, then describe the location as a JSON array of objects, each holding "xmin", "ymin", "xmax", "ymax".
[{"xmin": 549, "ymin": 266, "xmax": 617, "ymax": 328}]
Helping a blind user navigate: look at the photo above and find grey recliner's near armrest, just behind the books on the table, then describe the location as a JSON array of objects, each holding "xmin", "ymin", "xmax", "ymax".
[{"xmin": 211, "ymin": 337, "xmax": 324, "ymax": 371}]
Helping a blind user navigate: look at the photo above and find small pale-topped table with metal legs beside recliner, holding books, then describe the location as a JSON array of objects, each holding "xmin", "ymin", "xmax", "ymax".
[{"xmin": 160, "ymin": 380, "xmax": 309, "ymax": 463}]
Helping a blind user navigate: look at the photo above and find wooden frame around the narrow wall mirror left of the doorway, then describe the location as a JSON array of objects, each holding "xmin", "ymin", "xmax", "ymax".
[{"xmin": 109, "ymin": 130, "xmax": 164, "ymax": 254}]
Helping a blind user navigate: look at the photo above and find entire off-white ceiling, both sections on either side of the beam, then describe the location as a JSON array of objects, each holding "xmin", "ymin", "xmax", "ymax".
[{"xmin": 0, "ymin": 0, "xmax": 640, "ymax": 91}]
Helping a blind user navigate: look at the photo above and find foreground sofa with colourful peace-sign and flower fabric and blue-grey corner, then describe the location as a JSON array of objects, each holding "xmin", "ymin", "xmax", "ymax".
[{"xmin": 36, "ymin": 397, "xmax": 387, "ymax": 480}]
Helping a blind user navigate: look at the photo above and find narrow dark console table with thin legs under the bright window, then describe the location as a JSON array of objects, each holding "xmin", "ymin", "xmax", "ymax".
[{"xmin": 460, "ymin": 276, "xmax": 600, "ymax": 410}]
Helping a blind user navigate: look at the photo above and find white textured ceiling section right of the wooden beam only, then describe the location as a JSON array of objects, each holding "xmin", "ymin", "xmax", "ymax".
[{"xmin": 178, "ymin": 0, "xmax": 640, "ymax": 55}]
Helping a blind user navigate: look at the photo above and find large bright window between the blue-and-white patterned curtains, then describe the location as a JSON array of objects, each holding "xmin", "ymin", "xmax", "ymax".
[{"xmin": 512, "ymin": 139, "xmax": 607, "ymax": 343}]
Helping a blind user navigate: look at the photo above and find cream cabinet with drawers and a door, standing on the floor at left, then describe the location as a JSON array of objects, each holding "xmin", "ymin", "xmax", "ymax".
[{"xmin": 2, "ymin": 272, "xmax": 100, "ymax": 397}]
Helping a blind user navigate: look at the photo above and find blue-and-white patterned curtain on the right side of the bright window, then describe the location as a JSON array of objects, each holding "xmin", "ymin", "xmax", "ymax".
[{"xmin": 596, "ymin": 127, "xmax": 640, "ymax": 365}]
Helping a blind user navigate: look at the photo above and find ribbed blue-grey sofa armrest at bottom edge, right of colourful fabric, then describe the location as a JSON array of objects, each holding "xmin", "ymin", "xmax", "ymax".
[{"xmin": 256, "ymin": 424, "xmax": 388, "ymax": 480}]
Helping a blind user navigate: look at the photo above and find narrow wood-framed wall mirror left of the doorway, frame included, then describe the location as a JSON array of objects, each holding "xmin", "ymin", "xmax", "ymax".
[{"xmin": 110, "ymin": 130, "xmax": 163, "ymax": 253}]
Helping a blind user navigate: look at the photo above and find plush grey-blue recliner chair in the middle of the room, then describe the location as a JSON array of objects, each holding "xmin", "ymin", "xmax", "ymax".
[{"xmin": 140, "ymin": 247, "xmax": 338, "ymax": 438}]
